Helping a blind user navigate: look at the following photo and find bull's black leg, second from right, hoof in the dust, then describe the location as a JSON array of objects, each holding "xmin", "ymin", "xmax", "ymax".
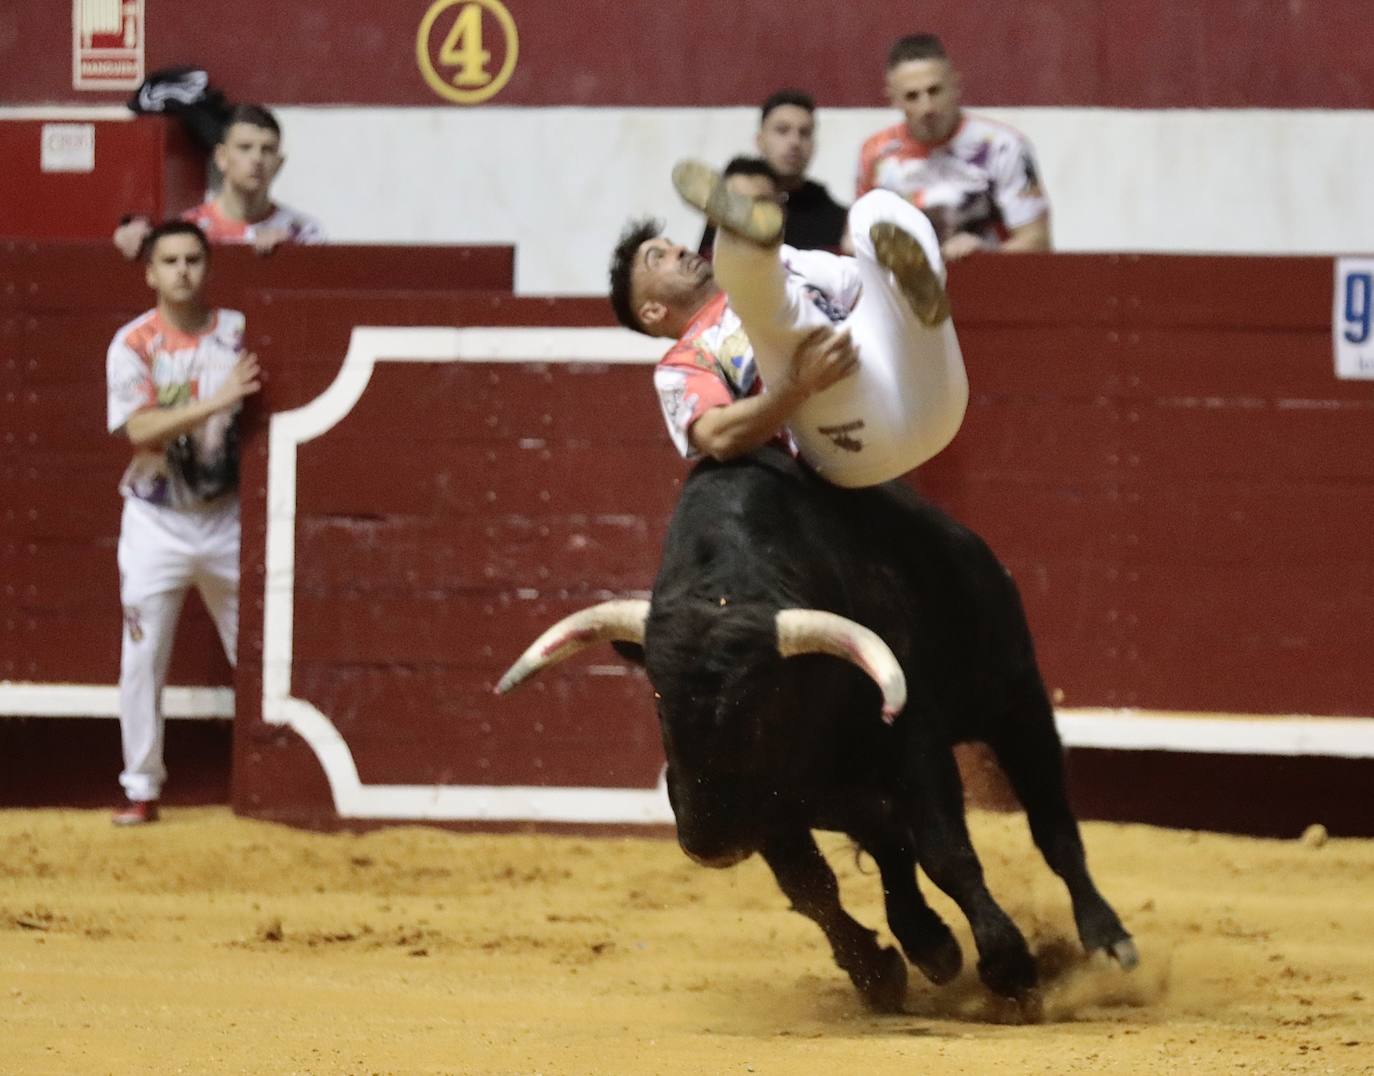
[{"xmin": 912, "ymin": 743, "xmax": 1036, "ymax": 998}]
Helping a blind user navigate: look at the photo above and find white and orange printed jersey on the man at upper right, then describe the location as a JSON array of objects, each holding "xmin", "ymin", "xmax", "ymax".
[{"xmin": 857, "ymin": 113, "xmax": 1050, "ymax": 245}]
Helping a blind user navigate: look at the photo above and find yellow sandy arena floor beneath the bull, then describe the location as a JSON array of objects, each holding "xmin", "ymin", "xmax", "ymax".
[{"xmin": 0, "ymin": 809, "xmax": 1374, "ymax": 1076}]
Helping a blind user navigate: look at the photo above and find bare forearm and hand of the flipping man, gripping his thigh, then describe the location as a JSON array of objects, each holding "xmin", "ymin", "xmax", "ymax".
[{"xmin": 687, "ymin": 328, "xmax": 859, "ymax": 460}]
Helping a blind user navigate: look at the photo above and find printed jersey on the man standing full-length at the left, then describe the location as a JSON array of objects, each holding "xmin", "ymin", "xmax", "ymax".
[{"xmin": 106, "ymin": 309, "xmax": 243, "ymax": 508}]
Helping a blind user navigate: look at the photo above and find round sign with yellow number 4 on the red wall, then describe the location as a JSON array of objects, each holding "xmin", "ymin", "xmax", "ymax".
[{"xmin": 415, "ymin": 0, "xmax": 519, "ymax": 104}]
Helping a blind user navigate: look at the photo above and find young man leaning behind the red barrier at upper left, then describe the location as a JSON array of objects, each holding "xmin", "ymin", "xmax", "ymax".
[{"xmin": 114, "ymin": 104, "xmax": 324, "ymax": 260}]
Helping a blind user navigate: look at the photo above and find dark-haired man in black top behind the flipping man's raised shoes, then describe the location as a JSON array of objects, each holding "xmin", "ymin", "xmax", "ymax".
[{"xmin": 698, "ymin": 89, "xmax": 849, "ymax": 254}]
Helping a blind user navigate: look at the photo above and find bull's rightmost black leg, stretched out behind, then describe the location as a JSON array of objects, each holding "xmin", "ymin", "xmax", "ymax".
[{"xmin": 988, "ymin": 682, "xmax": 1138, "ymax": 969}]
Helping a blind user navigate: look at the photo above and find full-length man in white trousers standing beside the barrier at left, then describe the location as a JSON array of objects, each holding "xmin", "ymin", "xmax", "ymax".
[{"xmin": 106, "ymin": 221, "xmax": 258, "ymax": 826}]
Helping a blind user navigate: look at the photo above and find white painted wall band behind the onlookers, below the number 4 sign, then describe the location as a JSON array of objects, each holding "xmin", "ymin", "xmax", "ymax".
[{"xmin": 10, "ymin": 103, "xmax": 1374, "ymax": 295}]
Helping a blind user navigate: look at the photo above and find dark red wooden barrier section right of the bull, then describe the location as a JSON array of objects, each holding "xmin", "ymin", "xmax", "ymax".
[{"xmin": 921, "ymin": 256, "xmax": 1374, "ymax": 715}]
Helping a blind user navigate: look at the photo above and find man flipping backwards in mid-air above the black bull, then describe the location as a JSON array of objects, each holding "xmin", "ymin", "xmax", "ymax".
[{"xmin": 610, "ymin": 161, "xmax": 969, "ymax": 486}]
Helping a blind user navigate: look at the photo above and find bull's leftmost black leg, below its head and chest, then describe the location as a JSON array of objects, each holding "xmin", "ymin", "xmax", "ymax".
[{"xmin": 763, "ymin": 830, "xmax": 907, "ymax": 1013}]
